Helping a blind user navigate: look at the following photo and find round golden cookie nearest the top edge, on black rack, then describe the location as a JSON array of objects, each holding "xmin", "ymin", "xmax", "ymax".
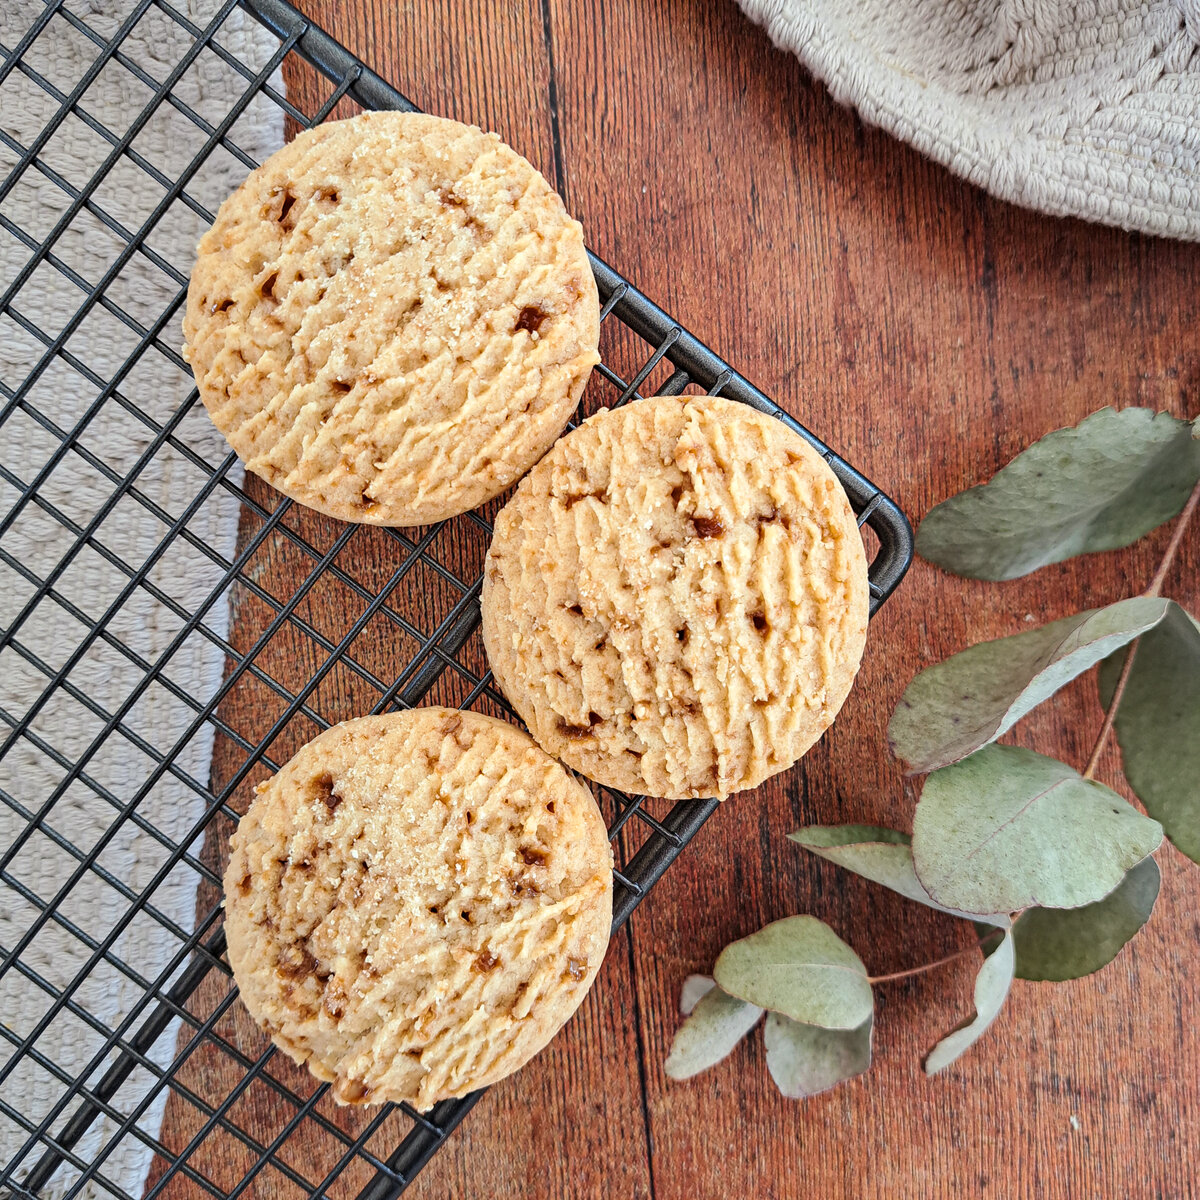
[{"xmin": 184, "ymin": 113, "xmax": 600, "ymax": 526}]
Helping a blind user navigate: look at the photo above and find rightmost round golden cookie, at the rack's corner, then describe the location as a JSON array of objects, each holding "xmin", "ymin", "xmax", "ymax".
[{"xmin": 482, "ymin": 396, "xmax": 868, "ymax": 799}]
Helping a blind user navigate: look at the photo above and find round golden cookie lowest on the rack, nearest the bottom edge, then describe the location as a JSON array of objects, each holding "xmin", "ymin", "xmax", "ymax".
[{"xmin": 224, "ymin": 708, "xmax": 612, "ymax": 1110}]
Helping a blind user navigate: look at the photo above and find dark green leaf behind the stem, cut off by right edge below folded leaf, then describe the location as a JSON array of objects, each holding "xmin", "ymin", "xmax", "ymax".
[{"xmin": 1100, "ymin": 604, "xmax": 1200, "ymax": 863}]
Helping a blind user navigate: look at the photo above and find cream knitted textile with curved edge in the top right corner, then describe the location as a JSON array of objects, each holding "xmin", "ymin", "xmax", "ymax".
[{"xmin": 738, "ymin": 0, "xmax": 1200, "ymax": 240}]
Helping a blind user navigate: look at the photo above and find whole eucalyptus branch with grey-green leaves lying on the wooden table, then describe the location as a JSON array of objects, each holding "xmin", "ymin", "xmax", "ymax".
[{"xmin": 665, "ymin": 408, "xmax": 1200, "ymax": 1098}]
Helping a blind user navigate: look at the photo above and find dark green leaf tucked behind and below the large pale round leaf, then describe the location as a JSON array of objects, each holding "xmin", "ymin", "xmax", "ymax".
[{"xmin": 1013, "ymin": 858, "xmax": 1160, "ymax": 983}]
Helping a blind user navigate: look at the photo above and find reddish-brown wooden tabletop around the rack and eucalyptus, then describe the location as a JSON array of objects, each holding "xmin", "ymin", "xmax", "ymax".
[{"xmin": 164, "ymin": 0, "xmax": 1200, "ymax": 1200}]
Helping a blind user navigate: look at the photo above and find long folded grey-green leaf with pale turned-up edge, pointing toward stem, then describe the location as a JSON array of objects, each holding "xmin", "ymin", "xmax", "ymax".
[{"xmin": 888, "ymin": 596, "xmax": 1169, "ymax": 773}]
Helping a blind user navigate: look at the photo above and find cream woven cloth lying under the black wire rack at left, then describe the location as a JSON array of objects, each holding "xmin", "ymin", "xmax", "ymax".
[{"xmin": 0, "ymin": 0, "xmax": 283, "ymax": 1198}]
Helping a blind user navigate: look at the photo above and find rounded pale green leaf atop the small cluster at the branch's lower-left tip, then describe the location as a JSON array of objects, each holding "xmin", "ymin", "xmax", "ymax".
[{"xmin": 713, "ymin": 917, "xmax": 875, "ymax": 1030}]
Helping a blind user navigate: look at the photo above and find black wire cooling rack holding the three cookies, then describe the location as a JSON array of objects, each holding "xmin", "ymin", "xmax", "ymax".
[{"xmin": 0, "ymin": 0, "xmax": 912, "ymax": 1200}]
